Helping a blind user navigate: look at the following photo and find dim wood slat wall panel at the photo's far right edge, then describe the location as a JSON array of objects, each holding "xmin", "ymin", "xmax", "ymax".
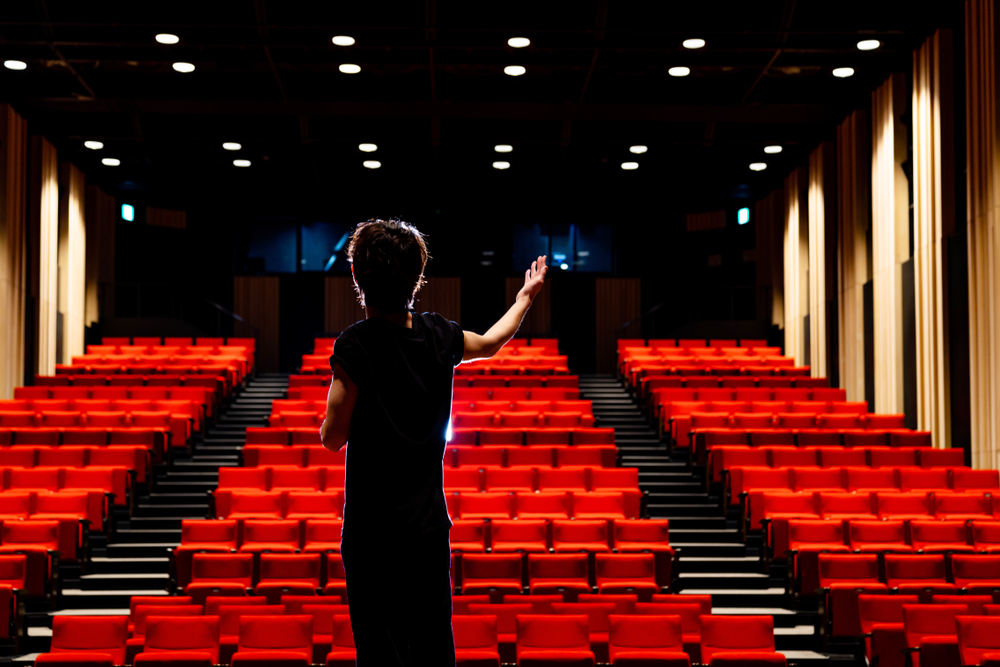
[{"xmin": 965, "ymin": 0, "xmax": 1000, "ymax": 468}]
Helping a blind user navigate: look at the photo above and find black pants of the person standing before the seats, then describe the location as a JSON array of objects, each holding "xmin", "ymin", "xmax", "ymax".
[{"xmin": 341, "ymin": 528, "xmax": 455, "ymax": 667}]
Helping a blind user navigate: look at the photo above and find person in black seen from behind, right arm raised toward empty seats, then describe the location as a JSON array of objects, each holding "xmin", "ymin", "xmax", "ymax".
[{"xmin": 320, "ymin": 220, "xmax": 547, "ymax": 667}]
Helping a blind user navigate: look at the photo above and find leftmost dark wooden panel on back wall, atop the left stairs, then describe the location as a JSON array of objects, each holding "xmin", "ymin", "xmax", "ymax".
[{"xmin": 233, "ymin": 276, "xmax": 281, "ymax": 373}]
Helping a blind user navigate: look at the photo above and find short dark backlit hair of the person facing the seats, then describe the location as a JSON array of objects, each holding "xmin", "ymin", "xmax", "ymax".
[{"xmin": 347, "ymin": 218, "xmax": 430, "ymax": 312}]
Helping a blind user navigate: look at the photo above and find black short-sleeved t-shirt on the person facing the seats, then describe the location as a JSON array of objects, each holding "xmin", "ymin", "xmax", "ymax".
[{"xmin": 330, "ymin": 313, "xmax": 465, "ymax": 541}]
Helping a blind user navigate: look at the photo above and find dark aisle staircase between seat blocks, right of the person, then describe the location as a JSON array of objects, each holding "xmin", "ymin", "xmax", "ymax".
[{"xmin": 580, "ymin": 376, "xmax": 855, "ymax": 665}]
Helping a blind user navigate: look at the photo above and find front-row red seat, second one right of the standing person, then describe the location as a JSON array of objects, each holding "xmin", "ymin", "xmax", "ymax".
[{"xmin": 517, "ymin": 615, "xmax": 595, "ymax": 667}]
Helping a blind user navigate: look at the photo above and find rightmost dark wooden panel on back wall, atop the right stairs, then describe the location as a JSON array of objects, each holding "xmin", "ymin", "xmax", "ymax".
[{"xmin": 594, "ymin": 278, "xmax": 642, "ymax": 374}]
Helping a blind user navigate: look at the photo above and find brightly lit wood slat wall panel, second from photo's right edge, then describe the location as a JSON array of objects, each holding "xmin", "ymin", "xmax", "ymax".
[{"xmin": 911, "ymin": 30, "xmax": 955, "ymax": 448}]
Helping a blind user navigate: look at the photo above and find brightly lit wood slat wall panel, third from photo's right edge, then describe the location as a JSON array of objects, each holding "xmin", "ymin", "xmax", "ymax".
[{"xmin": 871, "ymin": 74, "xmax": 910, "ymax": 413}]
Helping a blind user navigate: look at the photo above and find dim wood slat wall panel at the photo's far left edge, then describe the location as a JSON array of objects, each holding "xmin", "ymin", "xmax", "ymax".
[{"xmin": 0, "ymin": 104, "xmax": 28, "ymax": 399}]
